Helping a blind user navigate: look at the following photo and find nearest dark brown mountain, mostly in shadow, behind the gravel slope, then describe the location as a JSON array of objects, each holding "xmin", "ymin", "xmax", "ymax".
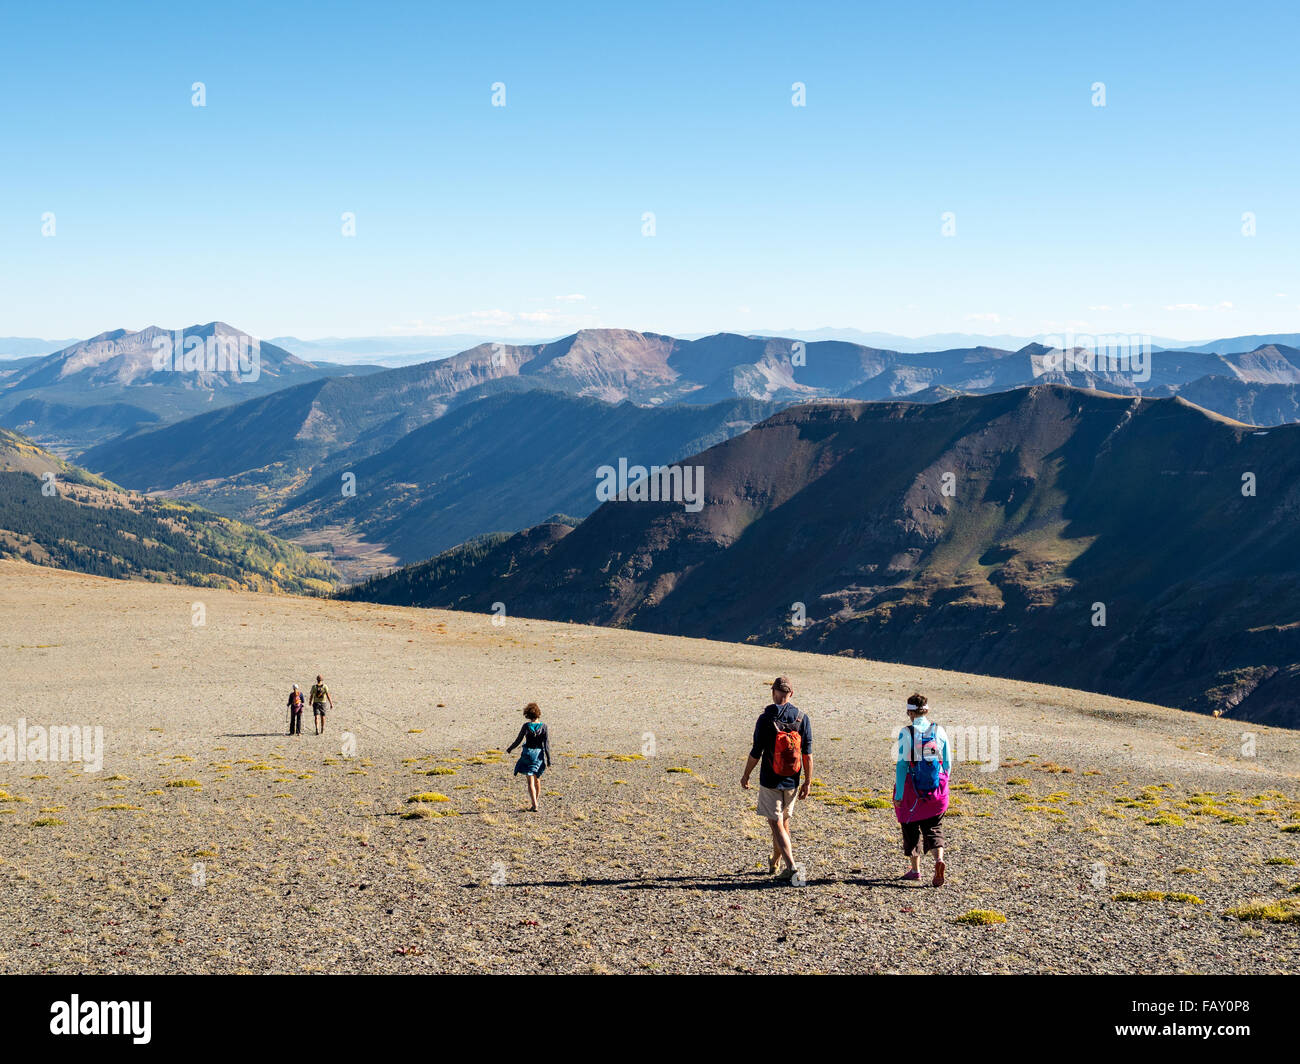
[{"xmin": 343, "ymin": 385, "xmax": 1300, "ymax": 726}]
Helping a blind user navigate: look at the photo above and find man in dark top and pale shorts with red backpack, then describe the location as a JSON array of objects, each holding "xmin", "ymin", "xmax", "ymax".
[{"xmin": 740, "ymin": 676, "xmax": 813, "ymax": 879}]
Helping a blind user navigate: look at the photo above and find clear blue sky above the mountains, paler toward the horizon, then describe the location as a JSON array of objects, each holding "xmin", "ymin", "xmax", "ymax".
[{"xmin": 0, "ymin": 0, "xmax": 1300, "ymax": 339}]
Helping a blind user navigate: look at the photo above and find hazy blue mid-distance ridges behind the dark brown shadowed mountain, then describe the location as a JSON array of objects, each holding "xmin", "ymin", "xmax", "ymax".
[{"xmin": 73, "ymin": 329, "xmax": 1300, "ymax": 575}]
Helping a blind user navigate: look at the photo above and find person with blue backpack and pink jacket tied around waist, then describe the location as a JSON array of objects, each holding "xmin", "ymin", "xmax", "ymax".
[{"xmin": 893, "ymin": 695, "xmax": 953, "ymax": 887}]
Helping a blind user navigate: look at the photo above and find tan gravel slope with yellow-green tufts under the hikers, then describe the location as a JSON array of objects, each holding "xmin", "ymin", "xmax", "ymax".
[{"xmin": 0, "ymin": 562, "xmax": 1300, "ymax": 973}]
